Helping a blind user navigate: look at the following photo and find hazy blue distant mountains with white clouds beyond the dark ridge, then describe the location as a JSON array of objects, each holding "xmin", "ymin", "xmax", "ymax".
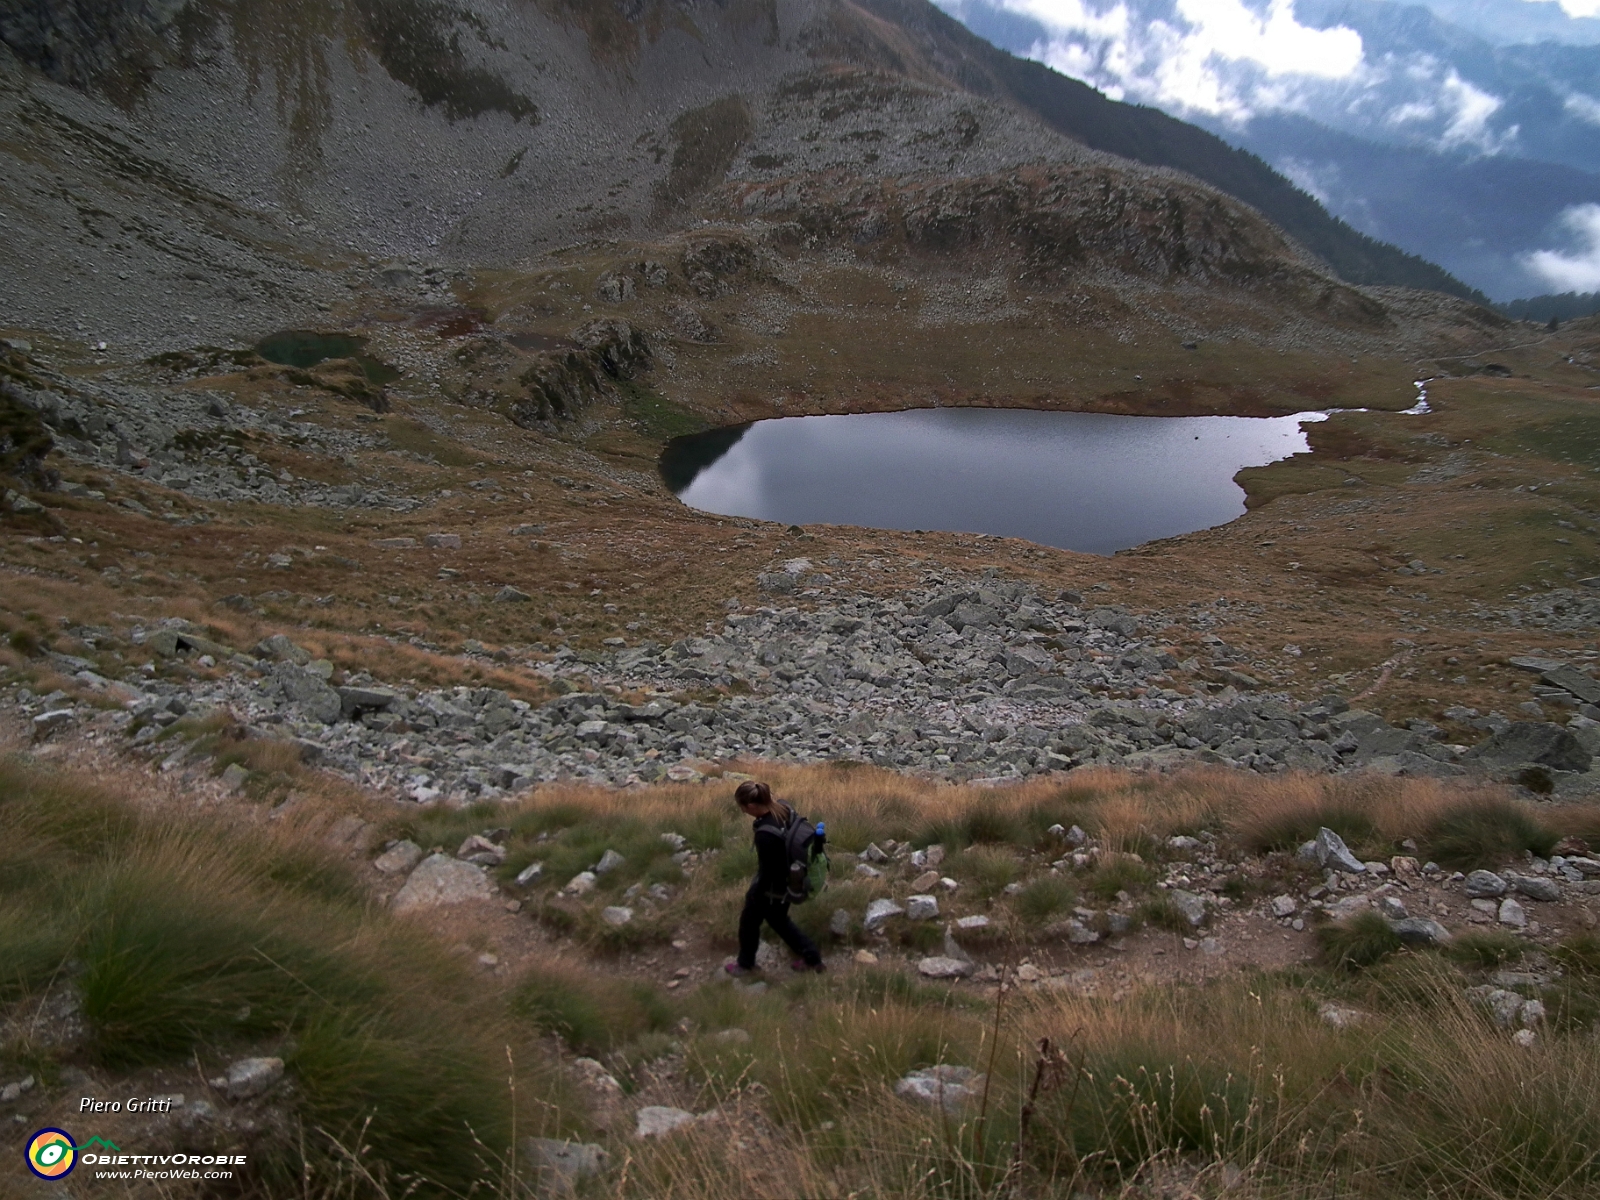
[{"xmin": 942, "ymin": 0, "xmax": 1600, "ymax": 299}]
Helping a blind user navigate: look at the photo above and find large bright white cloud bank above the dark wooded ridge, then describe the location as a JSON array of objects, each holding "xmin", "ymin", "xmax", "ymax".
[{"xmin": 941, "ymin": 0, "xmax": 1516, "ymax": 154}]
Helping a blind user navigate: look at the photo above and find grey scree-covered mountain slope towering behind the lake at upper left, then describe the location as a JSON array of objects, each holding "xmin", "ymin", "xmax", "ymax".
[{"xmin": 0, "ymin": 0, "xmax": 1491, "ymax": 349}]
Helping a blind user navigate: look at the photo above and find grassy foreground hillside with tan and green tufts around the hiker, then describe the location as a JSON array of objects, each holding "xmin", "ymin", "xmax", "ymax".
[{"xmin": 9, "ymin": 755, "xmax": 1600, "ymax": 1200}]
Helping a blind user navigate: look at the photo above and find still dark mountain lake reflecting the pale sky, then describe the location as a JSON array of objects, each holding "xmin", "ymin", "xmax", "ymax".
[{"xmin": 661, "ymin": 408, "xmax": 1323, "ymax": 554}]
